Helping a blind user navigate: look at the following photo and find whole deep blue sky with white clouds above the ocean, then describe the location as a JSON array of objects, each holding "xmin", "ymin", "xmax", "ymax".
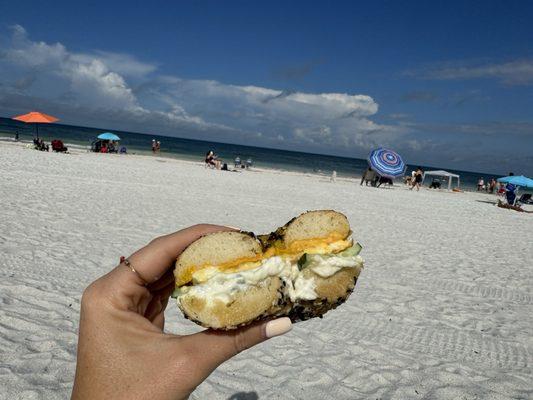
[{"xmin": 0, "ymin": 0, "xmax": 533, "ymax": 175}]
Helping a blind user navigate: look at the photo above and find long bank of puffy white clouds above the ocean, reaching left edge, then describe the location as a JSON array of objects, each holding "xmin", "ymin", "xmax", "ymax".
[{"xmin": 0, "ymin": 25, "xmax": 394, "ymax": 155}]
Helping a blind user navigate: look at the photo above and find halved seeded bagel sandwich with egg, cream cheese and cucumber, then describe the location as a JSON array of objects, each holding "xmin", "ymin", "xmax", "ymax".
[{"xmin": 173, "ymin": 210, "xmax": 363, "ymax": 330}]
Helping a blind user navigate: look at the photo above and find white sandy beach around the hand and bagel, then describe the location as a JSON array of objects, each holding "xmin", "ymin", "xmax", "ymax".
[{"xmin": 0, "ymin": 143, "xmax": 533, "ymax": 400}]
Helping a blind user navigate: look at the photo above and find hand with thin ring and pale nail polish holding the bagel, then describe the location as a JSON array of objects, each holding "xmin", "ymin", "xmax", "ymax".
[{"xmin": 72, "ymin": 225, "xmax": 291, "ymax": 400}]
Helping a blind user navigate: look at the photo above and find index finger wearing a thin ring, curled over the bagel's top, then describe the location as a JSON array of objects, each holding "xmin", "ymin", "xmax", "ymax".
[{"xmin": 114, "ymin": 224, "xmax": 234, "ymax": 285}]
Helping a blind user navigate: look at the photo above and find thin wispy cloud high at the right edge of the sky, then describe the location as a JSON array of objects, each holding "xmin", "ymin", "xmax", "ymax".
[{"xmin": 406, "ymin": 59, "xmax": 533, "ymax": 85}]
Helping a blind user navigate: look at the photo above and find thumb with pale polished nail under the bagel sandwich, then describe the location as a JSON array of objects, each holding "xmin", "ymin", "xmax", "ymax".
[{"xmin": 178, "ymin": 317, "xmax": 292, "ymax": 376}]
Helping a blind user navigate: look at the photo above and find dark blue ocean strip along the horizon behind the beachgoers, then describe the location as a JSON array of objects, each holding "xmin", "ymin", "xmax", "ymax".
[{"xmin": 0, "ymin": 118, "xmax": 498, "ymax": 190}]
